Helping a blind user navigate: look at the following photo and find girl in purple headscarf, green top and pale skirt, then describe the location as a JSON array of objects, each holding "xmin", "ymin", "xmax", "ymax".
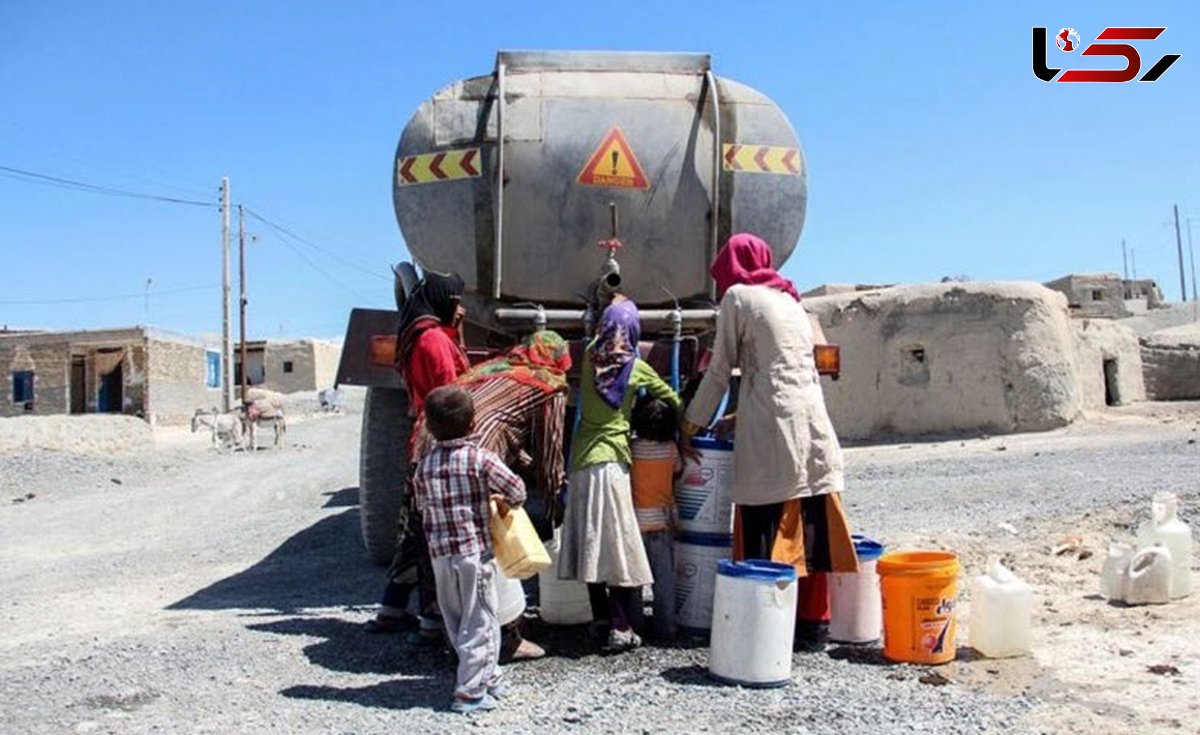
[{"xmin": 558, "ymin": 295, "xmax": 680, "ymax": 651}]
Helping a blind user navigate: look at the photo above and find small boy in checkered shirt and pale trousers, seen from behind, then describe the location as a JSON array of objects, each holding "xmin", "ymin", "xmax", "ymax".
[{"xmin": 413, "ymin": 386, "xmax": 526, "ymax": 712}]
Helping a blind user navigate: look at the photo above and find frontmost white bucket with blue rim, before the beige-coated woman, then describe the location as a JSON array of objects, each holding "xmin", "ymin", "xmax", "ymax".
[{"xmin": 708, "ymin": 560, "xmax": 796, "ymax": 687}]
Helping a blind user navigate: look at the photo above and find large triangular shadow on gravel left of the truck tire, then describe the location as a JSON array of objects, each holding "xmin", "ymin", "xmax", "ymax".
[{"xmin": 167, "ymin": 504, "xmax": 384, "ymax": 615}]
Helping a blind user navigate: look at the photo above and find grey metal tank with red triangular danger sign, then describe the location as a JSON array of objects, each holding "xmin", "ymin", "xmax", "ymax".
[{"xmin": 392, "ymin": 52, "xmax": 808, "ymax": 314}]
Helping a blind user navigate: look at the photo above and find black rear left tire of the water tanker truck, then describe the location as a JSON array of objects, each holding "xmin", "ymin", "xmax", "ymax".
[{"xmin": 359, "ymin": 388, "xmax": 412, "ymax": 566}]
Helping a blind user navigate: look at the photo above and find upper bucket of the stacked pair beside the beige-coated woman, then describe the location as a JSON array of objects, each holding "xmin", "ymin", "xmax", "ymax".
[{"xmin": 676, "ymin": 437, "xmax": 733, "ymax": 533}]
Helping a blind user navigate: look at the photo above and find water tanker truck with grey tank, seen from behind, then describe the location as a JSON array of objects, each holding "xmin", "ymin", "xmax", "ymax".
[{"xmin": 337, "ymin": 52, "xmax": 808, "ymax": 563}]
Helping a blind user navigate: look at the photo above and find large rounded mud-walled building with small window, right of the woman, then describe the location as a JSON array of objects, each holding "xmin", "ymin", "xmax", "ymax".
[{"xmin": 804, "ymin": 283, "xmax": 1080, "ymax": 438}]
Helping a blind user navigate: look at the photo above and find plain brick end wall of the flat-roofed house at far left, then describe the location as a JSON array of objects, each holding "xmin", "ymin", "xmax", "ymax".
[{"xmin": 146, "ymin": 339, "xmax": 221, "ymax": 425}]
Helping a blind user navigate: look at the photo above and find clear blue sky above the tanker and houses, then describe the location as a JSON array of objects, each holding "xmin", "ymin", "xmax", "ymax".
[{"xmin": 0, "ymin": 0, "xmax": 1200, "ymax": 337}]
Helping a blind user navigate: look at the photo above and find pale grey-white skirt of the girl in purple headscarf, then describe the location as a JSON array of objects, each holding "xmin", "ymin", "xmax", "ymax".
[{"xmin": 558, "ymin": 462, "xmax": 654, "ymax": 587}]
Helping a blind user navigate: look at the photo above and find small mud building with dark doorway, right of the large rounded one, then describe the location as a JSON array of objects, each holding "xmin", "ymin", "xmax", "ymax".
[{"xmin": 1073, "ymin": 319, "xmax": 1146, "ymax": 408}]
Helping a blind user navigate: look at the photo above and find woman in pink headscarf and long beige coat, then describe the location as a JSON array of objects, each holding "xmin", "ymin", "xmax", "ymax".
[{"xmin": 684, "ymin": 233, "xmax": 858, "ymax": 644}]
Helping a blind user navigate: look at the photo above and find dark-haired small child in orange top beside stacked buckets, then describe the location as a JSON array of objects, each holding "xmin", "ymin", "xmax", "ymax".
[{"xmin": 630, "ymin": 395, "xmax": 683, "ymax": 640}]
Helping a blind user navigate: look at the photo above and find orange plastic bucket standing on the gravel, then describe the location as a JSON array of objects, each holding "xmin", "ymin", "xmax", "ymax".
[{"xmin": 875, "ymin": 551, "xmax": 960, "ymax": 664}]
